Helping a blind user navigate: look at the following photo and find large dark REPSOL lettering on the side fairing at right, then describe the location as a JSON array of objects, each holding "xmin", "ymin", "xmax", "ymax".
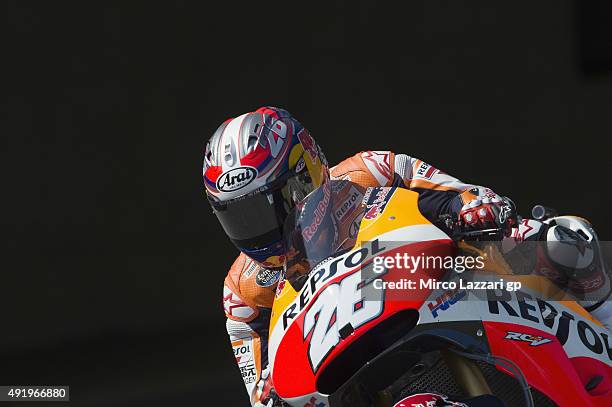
[{"xmin": 487, "ymin": 291, "xmax": 612, "ymax": 364}]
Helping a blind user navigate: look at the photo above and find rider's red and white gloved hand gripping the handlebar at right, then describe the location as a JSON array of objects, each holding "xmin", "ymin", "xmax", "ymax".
[{"xmin": 459, "ymin": 188, "xmax": 514, "ymax": 234}]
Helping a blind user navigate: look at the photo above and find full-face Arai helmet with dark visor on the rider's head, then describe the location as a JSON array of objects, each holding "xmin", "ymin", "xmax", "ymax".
[{"xmin": 204, "ymin": 107, "xmax": 329, "ymax": 267}]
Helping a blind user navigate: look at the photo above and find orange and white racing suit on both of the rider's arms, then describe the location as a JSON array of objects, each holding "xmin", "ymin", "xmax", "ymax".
[{"xmin": 223, "ymin": 151, "xmax": 506, "ymax": 406}]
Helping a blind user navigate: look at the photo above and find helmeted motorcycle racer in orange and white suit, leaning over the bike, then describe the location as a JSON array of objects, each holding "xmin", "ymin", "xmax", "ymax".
[{"xmin": 203, "ymin": 107, "xmax": 612, "ymax": 406}]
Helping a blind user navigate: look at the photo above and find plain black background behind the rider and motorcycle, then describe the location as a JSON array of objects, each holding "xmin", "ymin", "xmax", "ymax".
[{"xmin": 0, "ymin": 0, "xmax": 612, "ymax": 406}]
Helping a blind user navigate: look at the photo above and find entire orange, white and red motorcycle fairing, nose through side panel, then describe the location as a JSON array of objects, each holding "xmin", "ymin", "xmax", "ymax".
[{"xmin": 269, "ymin": 186, "xmax": 612, "ymax": 407}]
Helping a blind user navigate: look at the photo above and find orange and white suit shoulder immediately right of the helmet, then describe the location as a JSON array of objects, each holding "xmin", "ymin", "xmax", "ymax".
[{"xmin": 331, "ymin": 151, "xmax": 395, "ymax": 187}]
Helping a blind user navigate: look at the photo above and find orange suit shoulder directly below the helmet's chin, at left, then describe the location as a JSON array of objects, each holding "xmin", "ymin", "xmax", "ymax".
[{"xmin": 223, "ymin": 253, "xmax": 280, "ymax": 322}]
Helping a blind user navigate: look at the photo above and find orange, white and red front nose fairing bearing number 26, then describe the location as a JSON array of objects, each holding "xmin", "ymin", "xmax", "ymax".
[{"xmin": 269, "ymin": 188, "xmax": 453, "ymax": 399}]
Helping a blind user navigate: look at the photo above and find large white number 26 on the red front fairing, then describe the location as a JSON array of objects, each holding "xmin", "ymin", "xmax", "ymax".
[{"xmin": 304, "ymin": 272, "xmax": 384, "ymax": 372}]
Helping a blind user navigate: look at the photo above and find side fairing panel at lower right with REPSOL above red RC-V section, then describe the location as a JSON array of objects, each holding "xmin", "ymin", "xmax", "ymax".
[{"xmin": 417, "ymin": 276, "xmax": 612, "ymax": 406}]
